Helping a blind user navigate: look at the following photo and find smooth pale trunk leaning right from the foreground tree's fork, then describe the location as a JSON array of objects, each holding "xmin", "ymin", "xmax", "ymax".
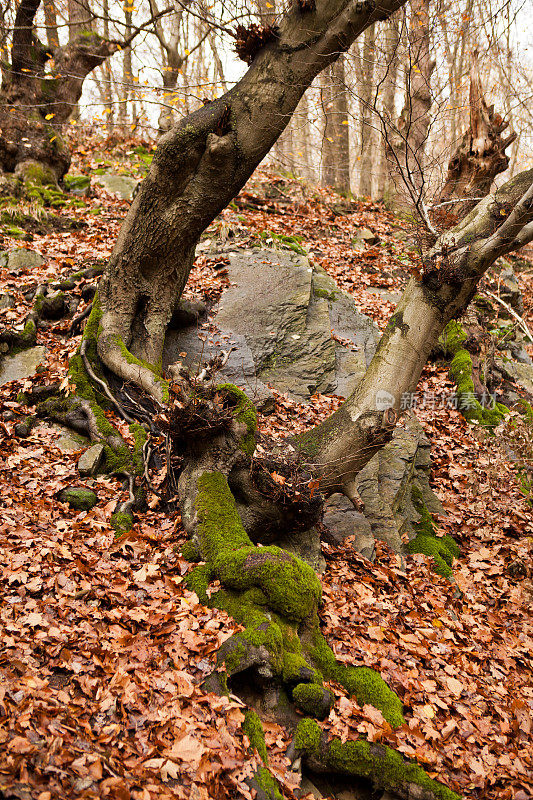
[{"xmin": 298, "ymin": 170, "xmax": 533, "ymax": 497}]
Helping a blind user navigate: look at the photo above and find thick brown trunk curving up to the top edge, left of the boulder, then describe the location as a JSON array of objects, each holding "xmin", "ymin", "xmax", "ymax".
[{"xmin": 93, "ymin": 0, "xmax": 403, "ymax": 399}]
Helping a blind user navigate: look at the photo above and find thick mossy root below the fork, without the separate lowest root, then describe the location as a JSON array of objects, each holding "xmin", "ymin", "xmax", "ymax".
[{"xmin": 187, "ymin": 472, "xmax": 403, "ymax": 727}]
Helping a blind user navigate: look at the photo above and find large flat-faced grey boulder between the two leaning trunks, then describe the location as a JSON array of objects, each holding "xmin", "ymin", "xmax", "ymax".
[{"xmin": 163, "ymin": 250, "xmax": 379, "ymax": 403}]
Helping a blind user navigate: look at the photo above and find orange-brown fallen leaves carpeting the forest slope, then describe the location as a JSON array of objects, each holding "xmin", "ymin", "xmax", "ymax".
[{"xmin": 0, "ymin": 144, "xmax": 533, "ymax": 800}]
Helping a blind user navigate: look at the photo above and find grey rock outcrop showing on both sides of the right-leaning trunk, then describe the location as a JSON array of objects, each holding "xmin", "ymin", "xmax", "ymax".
[{"xmin": 163, "ymin": 250, "xmax": 443, "ymax": 556}]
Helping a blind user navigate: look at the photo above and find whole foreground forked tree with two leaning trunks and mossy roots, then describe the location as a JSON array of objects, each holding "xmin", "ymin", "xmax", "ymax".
[{"xmin": 7, "ymin": 0, "xmax": 533, "ymax": 800}]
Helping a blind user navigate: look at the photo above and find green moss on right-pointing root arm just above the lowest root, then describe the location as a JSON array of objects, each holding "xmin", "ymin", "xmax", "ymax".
[{"xmin": 309, "ymin": 622, "xmax": 404, "ymax": 728}]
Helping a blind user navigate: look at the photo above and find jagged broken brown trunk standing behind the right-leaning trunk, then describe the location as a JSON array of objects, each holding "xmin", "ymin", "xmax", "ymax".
[{"xmin": 439, "ymin": 54, "xmax": 516, "ymax": 218}]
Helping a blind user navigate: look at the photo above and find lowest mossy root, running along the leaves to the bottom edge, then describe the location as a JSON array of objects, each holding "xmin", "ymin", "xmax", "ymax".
[{"xmin": 294, "ymin": 719, "xmax": 460, "ymax": 800}]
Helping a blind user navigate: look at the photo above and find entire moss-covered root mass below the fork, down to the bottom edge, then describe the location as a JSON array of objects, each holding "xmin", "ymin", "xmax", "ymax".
[{"xmin": 182, "ymin": 469, "xmax": 455, "ymax": 800}]
